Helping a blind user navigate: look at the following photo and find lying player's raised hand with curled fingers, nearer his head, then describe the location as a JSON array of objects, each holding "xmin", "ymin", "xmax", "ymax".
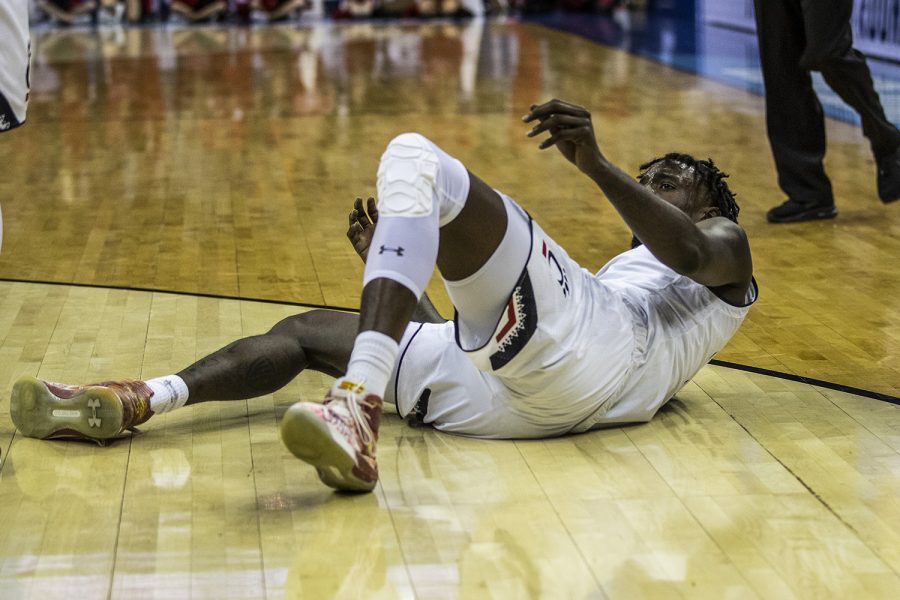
[{"xmin": 522, "ymin": 99, "xmax": 604, "ymax": 176}]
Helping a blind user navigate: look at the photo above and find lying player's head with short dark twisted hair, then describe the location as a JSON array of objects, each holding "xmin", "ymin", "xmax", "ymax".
[{"xmin": 638, "ymin": 152, "xmax": 740, "ymax": 223}]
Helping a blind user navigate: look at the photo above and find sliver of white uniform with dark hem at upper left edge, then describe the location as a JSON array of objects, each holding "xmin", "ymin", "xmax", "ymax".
[{"xmin": 0, "ymin": 0, "xmax": 30, "ymax": 252}]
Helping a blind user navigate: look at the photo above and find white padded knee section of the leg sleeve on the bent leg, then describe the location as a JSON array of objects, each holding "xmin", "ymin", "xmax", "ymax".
[{"xmin": 376, "ymin": 133, "xmax": 469, "ymax": 226}]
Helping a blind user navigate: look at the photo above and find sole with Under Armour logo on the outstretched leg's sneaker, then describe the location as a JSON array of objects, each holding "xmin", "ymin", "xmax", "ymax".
[{"xmin": 9, "ymin": 377, "xmax": 124, "ymax": 440}]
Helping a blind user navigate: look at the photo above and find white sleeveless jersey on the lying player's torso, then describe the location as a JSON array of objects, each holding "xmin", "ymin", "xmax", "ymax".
[{"xmin": 578, "ymin": 246, "xmax": 757, "ymax": 429}]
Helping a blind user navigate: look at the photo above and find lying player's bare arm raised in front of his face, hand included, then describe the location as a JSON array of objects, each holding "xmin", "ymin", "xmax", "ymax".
[{"xmin": 522, "ymin": 100, "xmax": 752, "ymax": 290}]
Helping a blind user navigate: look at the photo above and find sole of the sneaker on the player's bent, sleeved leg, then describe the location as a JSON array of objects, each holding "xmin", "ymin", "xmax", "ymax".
[{"xmin": 281, "ymin": 409, "xmax": 375, "ymax": 492}]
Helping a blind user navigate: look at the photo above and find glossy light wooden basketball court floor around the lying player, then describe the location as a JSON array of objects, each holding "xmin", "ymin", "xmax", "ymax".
[{"xmin": 0, "ymin": 14, "xmax": 900, "ymax": 599}]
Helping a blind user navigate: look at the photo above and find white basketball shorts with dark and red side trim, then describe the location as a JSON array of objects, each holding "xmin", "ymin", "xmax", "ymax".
[{"xmin": 385, "ymin": 204, "xmax": 638, "ymax": 438}]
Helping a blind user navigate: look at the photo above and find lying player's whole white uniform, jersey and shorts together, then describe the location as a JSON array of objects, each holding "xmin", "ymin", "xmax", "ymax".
[{"xmin": 385, "ymin": 197, "xmax": 757, "ymax": 438}]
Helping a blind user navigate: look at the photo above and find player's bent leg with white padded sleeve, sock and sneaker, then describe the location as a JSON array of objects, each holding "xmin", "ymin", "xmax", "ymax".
[{"xmin": 282, "ymin": 134, "xmax": 520, "ymax": 491}]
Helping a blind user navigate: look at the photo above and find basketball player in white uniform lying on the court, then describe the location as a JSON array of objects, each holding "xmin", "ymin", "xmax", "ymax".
[{"xmin": 10, "ymin": 100, "xmax": 757, "ymax": 491}]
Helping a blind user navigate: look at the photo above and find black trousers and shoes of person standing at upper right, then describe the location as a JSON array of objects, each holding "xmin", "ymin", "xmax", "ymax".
[{"xmin": 754, "ymin": 0, "xmax": 900, "ymax": 223}]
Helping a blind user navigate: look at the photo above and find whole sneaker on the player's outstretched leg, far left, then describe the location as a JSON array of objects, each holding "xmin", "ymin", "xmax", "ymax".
[{"xmin": 9, "ymin": 377, "xmax": 153, "ymax": 444}]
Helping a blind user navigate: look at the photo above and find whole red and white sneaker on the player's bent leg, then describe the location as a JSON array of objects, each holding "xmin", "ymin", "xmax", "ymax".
[{"xmin": 281, "ymin": 390, "xmax": 383, "ymax": 492}]
